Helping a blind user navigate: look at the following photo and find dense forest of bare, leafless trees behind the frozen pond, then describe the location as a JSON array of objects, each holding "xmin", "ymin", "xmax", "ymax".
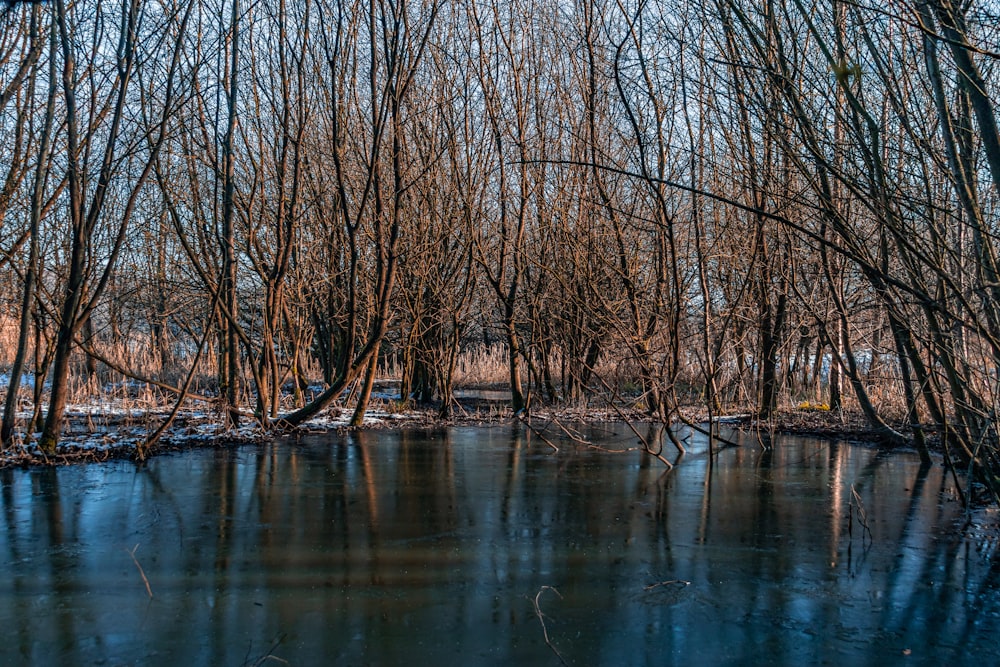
[{"xmin": 0, "ymin": 0, "xmax": 1000, "ymax": 497}]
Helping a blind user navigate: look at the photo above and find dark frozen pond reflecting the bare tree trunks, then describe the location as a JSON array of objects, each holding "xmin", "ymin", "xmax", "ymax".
[{"xmin": 0, "ymin": 426, "xmax": 1000, "ymax": 666}]
